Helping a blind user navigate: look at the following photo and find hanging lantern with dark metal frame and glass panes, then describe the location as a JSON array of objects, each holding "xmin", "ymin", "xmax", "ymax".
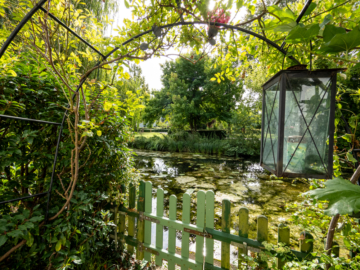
[{"xmin": 260, "ymin": 65, "xmax": 343, "ymax": 179}]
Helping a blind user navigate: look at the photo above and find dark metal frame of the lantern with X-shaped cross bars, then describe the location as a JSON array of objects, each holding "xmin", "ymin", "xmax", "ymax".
[{"xmin": 260, "ymin": 67, "xmax": 344, "ymax": 179}]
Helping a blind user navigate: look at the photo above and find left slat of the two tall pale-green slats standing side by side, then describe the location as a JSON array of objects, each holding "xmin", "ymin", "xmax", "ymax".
[{"xmin": 195, "ymin": 190, "xmax": 205, "ymax": 263}]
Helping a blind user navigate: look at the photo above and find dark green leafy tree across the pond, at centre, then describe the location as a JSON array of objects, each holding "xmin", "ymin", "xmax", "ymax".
[{"xmin": 144, "ymin": 55, "xmax": 242, "ymax": 131}]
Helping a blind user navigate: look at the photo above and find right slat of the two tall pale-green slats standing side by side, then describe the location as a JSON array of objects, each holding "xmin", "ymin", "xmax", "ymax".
[{"xmin": 205, "ymin": 190, "xmax": 214, "ymax": 264}]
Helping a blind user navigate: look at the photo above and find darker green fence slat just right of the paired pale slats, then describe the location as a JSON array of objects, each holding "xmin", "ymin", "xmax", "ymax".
[{"xmin": 221, "ymin": 200, "xmax": 231, "ymax": 269}]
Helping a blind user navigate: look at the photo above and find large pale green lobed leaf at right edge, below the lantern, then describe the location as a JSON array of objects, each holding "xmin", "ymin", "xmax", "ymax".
[{"xmin": 304, "ymin": 178, "xmax": 360, "ymax": 216}]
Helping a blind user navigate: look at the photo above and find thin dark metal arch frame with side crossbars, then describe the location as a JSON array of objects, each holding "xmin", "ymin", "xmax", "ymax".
[{"xmin": 0, "ymin": 0, "xmax": 312, "ymax": 222}]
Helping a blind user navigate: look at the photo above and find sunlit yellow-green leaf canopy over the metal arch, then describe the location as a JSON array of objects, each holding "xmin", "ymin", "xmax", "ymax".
[{"xmin": 1, "ymin": 0, "xmax": 360, "ymax": 96}]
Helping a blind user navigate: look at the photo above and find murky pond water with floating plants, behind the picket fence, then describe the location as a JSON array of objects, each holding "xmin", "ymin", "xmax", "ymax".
[{"xmin": 135, "ymin": 150, "xmax": 308, "ymax": 265}]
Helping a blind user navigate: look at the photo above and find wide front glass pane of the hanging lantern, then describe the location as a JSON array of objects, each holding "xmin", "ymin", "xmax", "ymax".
[{"xmin": 283, "ymin": 77, "xmax": 331, "ymax": 175}]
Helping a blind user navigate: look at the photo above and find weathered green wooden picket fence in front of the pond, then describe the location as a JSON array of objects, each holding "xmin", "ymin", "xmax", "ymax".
[{"xmin": 111, "ymin": 181, "xmax": 339, "ymax": 270}]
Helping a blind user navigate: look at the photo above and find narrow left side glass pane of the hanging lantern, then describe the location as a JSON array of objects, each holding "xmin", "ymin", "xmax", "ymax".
[{"xmin": 263, "ymin": 83, "xmax": 280, "ymax": 170}]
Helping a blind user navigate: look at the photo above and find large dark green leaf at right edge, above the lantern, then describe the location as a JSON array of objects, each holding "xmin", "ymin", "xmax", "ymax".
[{"xmin": 319, "ymin": 29, "xmax": 360, "ymax": 53}]
